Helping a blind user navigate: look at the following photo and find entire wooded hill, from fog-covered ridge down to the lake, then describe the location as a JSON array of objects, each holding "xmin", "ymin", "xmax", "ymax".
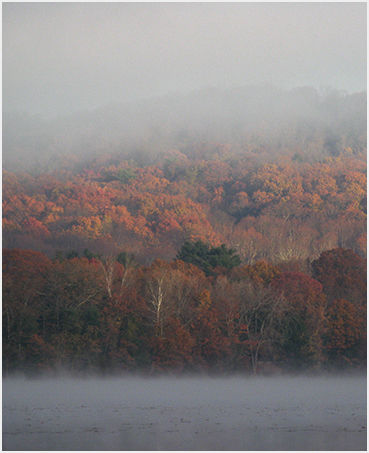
[{"xmin": 3, "ymin": 87, "xmax": 366, "ymax": 373}]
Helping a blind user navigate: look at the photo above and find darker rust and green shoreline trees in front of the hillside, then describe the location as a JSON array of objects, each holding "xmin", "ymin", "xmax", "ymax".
[{"xmin": 2, "ymin": 241, "xmax": 366, "ymax": 373}]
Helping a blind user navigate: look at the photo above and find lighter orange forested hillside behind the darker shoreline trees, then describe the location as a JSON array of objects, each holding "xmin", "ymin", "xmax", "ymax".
[{"xmin": 3, "ymin": 148, "xmax": 366, "ymax": 264}]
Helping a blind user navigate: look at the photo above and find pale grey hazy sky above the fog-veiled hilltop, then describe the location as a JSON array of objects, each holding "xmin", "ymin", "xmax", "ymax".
[{"xmin": 2, "ymin": 2, "xmax": 367, "ymax": 116}]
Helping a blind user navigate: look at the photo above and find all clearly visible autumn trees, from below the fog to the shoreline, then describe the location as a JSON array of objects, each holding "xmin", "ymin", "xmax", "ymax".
[{"xmin": 3, "ymin": 143, "xmax": 366, "ymax": 373}]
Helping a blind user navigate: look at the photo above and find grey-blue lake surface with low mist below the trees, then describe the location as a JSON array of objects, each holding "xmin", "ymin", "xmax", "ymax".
[{"xmin": 3, "ymin": 376, "xmax": 366, "ymax": 451}]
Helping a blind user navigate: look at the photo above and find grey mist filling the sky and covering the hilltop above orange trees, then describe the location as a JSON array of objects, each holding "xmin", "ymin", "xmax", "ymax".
[{"xmin": 3, "ymin": 2, "xmax": 366, "ymax": 172}]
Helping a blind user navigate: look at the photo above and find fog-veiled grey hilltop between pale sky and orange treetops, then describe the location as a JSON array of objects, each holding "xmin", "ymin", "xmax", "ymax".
[{"xmin": 3, "ymin": 85, "xmax": 366, "ymax": 171}]
